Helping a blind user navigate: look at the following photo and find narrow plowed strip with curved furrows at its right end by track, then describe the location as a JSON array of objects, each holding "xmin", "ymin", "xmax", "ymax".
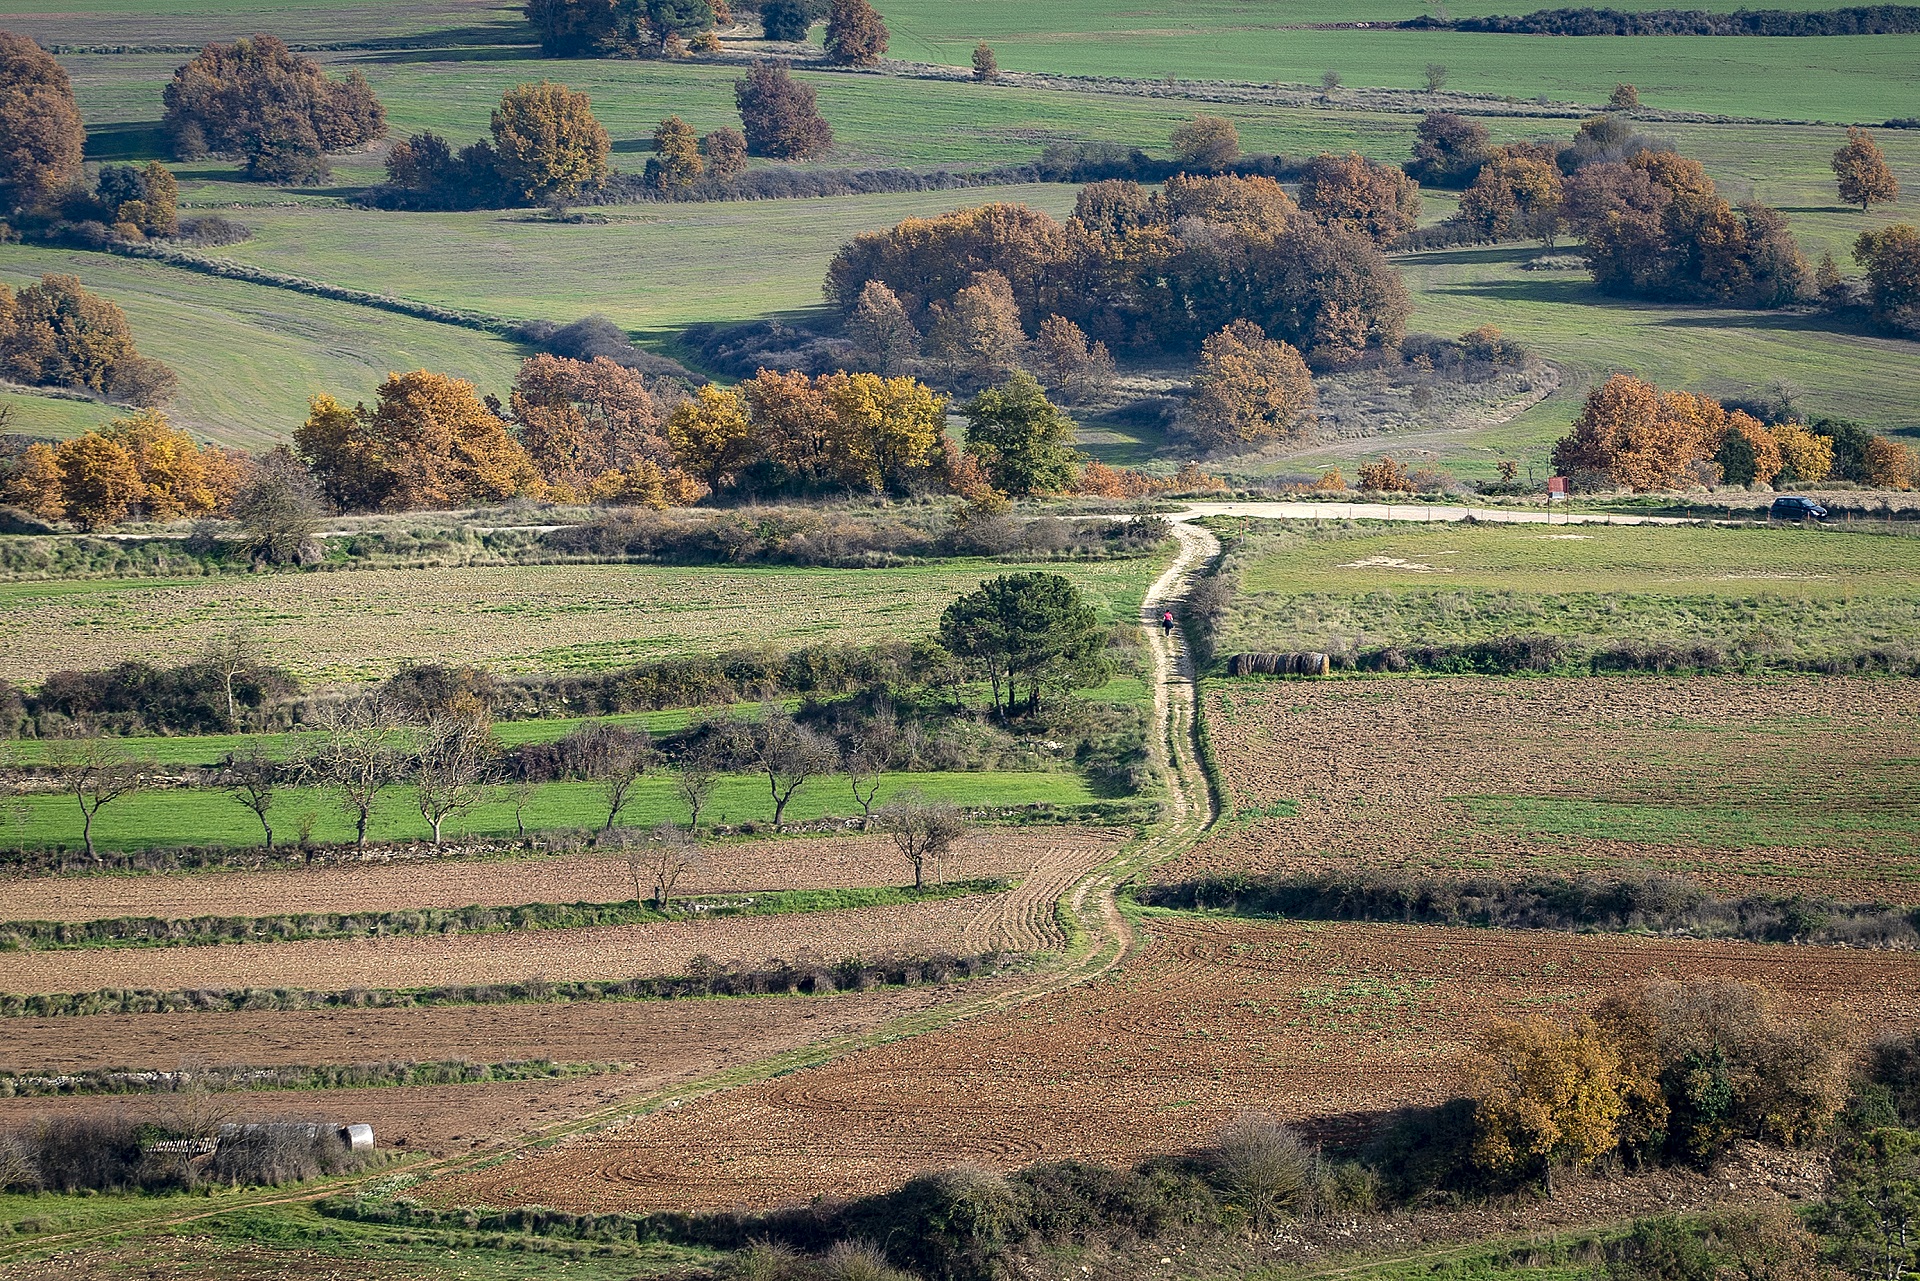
[{"xmin": 0, "ymin": 830, "xmax": 1119, "ymax": 993}]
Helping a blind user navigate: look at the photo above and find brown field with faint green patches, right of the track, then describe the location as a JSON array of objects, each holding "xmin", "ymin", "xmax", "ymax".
[{"xmin": 1156, "ymin": 676, "xmax": 1920, "ymax": 903}]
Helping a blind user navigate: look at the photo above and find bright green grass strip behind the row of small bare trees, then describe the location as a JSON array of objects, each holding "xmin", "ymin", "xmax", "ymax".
[{"xmin": 0, "ymin": 770, "xmax": 1094, "ymax": 849}]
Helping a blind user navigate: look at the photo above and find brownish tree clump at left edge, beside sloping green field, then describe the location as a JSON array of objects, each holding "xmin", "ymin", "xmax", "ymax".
[{"xmin": 0, "ymin": 275, "xmax": 177, "ymax": 405}]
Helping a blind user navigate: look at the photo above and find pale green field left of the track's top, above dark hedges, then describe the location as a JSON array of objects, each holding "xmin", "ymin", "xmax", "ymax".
[{"xmin": 0, "ymin": 557, "xmax": 1160, "ymax": 682}]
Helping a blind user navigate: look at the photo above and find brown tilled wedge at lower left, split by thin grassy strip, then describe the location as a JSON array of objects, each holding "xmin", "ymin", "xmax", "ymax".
[{"xmin": 0, "ymin": 976, "xmax": 1021, "ymax": 1152}]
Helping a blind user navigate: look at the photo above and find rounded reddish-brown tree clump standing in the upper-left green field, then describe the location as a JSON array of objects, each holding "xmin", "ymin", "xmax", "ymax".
[{"xmin": 161, "ymin": 35, "xmax": 386, "ymax": 182}]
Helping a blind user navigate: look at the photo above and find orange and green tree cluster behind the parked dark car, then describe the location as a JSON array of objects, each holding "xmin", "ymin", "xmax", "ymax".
[{"xmin": 1553, "ymin": 375, "xmax": 1920, "ymax": 494}]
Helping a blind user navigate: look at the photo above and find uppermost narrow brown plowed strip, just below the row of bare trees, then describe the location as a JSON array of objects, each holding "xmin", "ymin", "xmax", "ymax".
[{"xmin": 0, "ymin": 832, "xmax": 1082, "ymax": 920}]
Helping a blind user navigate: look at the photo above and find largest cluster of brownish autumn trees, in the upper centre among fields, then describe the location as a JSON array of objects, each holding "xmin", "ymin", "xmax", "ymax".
[{"xmin": 826, "ymin": 165, "xmax": 1409, "ymax": 367}]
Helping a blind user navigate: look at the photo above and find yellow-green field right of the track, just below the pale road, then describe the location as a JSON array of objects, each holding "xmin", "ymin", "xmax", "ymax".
[{"xmin": 1215, "ymin": 524, "xmax": 1920, "ymax": 661}]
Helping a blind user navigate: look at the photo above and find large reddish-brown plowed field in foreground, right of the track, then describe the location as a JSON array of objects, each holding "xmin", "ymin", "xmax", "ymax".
[{"xmin": 424, "ymin": 918, "xmax": 1920, "ymax": 1210}]
